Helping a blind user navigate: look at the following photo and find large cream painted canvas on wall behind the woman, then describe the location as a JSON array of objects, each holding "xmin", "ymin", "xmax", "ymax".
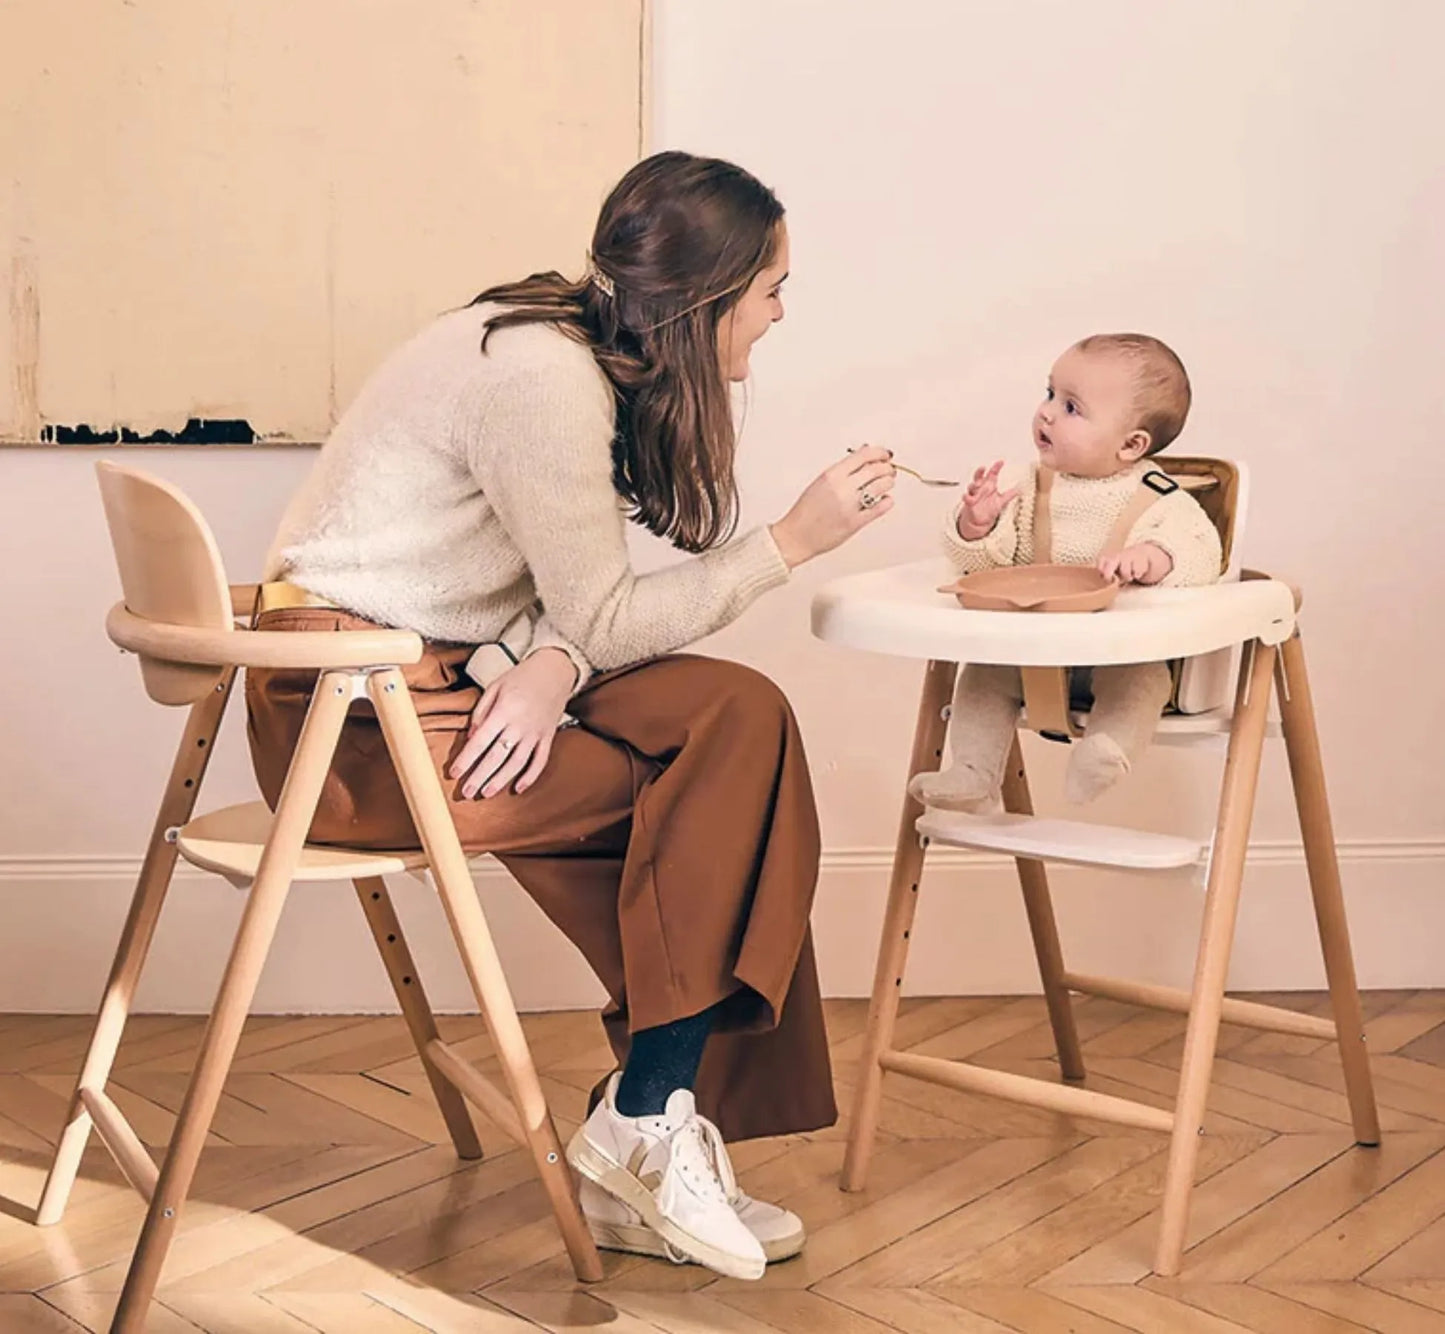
[{"xmin": 0, "ymin": 0, "xmax": 646, "ymax": 445}]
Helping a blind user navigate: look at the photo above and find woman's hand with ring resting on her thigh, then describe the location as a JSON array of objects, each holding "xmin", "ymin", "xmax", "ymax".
[{"xmin": 447, "ymin": 647, "xmax": 577, "ymax": 798}]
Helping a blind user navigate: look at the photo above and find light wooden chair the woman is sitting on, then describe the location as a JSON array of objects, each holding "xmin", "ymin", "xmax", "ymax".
[{"xmin": 36, "ymin": 462, "xmax": 603, "ymax": 1334}]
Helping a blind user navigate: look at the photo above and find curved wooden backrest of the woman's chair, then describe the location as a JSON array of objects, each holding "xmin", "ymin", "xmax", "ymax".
[{"xmin": 95, "ymin": 461, "xmax": 233, "ymax": 704}]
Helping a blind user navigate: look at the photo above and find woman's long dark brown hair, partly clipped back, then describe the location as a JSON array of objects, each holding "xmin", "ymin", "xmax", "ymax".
[{"xmin": 473, "ymin": 152, "xmax": 783, "ymax": 552}]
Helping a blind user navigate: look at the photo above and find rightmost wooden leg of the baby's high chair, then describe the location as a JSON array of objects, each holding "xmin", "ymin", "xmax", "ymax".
[{"xmin": 1276, "ymin": 632, "xmax": 1380, "ymax": 1145}]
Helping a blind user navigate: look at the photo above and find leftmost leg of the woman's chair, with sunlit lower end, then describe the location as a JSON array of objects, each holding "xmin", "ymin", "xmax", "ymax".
[{"xmin": 35, "ymin": 668, "xmax": 236, "ymax": 1227}]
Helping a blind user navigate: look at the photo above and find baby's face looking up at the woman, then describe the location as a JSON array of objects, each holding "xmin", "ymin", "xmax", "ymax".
[{"xmin": 1033, "ymin": 347, "xmax": 1147, "ymax": 477}]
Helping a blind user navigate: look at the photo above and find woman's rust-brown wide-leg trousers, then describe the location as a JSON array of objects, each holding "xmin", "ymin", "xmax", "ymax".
[{"xmin": 246, "ymin": 607, "xmax": 837, "ymax": 1140}]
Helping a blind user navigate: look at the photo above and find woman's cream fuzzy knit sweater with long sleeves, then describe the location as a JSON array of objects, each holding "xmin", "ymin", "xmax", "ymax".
[{"xmin": 266, "ymin": 306, "xmax": 788, "ymax": 685}]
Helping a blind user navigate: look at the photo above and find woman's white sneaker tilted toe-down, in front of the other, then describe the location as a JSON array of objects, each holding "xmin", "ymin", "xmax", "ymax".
[{"xmin": 566, "ymin": 1074, "xmax": 767, "ymax": 1279}]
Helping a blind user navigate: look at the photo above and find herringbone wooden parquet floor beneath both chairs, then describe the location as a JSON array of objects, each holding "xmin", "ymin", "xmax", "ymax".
[{"xmin": 0, "ymin": 991, "xmax": 1445, "ymax": 1334}]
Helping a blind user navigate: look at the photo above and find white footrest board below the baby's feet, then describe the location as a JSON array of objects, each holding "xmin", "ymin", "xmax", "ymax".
[{"xmin": 916, "ymin": 811, "xmax": 1208, "ymax": 870}]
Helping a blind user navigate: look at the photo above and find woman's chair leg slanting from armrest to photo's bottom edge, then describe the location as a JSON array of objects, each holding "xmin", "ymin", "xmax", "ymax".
[{"xmin": 110, "ymin": 672, "xmax": 351, "ymax": 1334}]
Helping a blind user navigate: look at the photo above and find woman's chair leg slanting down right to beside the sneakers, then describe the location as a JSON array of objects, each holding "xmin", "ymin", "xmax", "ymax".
[{"xmin": 367, "ymin": 668, "xmax": 603, "ymax": 1282}]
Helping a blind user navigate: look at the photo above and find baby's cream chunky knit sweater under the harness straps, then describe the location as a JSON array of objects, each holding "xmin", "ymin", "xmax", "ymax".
[{"xmin": 944, "ymin": 460, "xmax": 1222, "ymax": 588}]
